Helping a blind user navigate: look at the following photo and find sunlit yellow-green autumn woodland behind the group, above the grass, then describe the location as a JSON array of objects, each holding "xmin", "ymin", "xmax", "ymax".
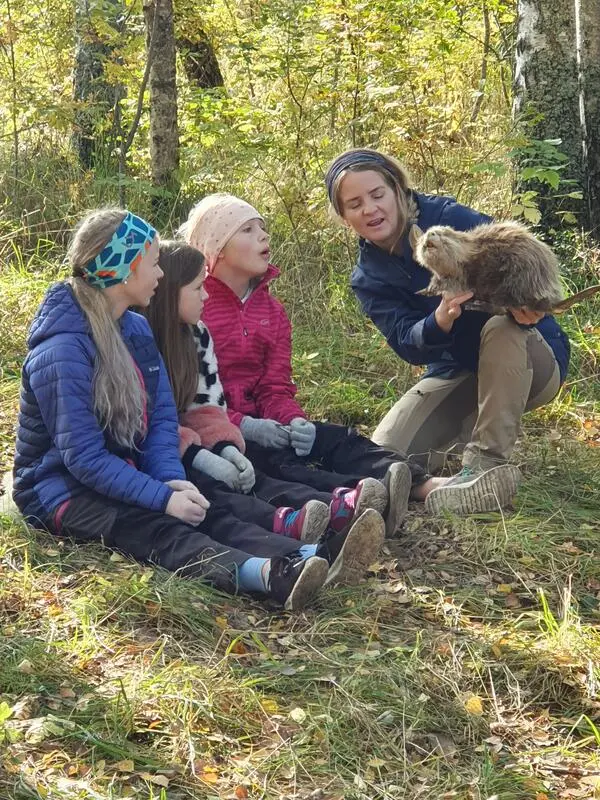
[{"xmin": 0, "ymin": 0, "xmax": 600, "ymax": 238}]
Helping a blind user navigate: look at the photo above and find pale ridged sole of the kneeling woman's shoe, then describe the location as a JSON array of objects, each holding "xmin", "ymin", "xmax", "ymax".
[{"xmin": 425, "ymin": 464, "xmax": 521, "ymax": 515}]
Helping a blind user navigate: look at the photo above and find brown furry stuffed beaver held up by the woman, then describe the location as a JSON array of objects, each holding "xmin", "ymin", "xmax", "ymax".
[{"xmin": 410, "ymin": 222, "xmax": 600, "ymax": 314}]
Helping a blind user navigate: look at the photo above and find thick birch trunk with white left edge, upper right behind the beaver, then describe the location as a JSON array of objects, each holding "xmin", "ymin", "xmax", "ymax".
[{"xmin": 514, "ymin": 0, "xmax": 583, "ymax": 225}]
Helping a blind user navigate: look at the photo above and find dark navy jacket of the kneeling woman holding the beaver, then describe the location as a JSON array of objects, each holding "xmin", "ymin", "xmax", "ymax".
[{"xmin": 351, "ymin": 192, "xmax": 570, "ymax": 381}]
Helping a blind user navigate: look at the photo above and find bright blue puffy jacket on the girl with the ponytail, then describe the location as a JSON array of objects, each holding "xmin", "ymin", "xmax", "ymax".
[{"xmin": 13, "ymin": 283, "xmax": 185, "ymax": 525}]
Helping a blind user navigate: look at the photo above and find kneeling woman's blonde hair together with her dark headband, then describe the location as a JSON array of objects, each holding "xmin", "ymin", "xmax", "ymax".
[{"xmin": 325, "ymin": 148, "xmax": 418, "ymax": 250}]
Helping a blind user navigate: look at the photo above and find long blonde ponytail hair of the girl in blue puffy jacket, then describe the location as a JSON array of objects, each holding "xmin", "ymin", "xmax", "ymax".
[{"xmin": 68, "ymin": 208, "xmax": 146, "ymax": 449}]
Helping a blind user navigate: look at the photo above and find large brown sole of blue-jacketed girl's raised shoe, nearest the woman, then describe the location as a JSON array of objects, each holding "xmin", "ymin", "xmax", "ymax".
[{"xmin": 325, "ymin": 508, "xmax": 385, "ymax": 586}]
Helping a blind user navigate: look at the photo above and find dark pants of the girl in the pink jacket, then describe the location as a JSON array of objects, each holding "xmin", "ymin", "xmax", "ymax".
[{"xmin": 246, "ymin": 422, "xmax": 428, "ymax": 492}]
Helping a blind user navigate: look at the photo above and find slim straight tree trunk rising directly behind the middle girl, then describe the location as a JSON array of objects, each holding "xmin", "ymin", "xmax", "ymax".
[{"xmin": 144, "ymin": 0, "xmax": 179, "ymax": 208}]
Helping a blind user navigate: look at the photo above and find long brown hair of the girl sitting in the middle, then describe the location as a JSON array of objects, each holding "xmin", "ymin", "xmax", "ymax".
[{"xmin": 145, "ymin": 241, "xmax": 204, "ymax": 414}]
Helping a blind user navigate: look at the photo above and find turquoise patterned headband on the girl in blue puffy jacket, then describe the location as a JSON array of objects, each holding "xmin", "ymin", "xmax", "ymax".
[{"xmin": 83, "ymin": 211, "xmax": 156, "ymax": 289}]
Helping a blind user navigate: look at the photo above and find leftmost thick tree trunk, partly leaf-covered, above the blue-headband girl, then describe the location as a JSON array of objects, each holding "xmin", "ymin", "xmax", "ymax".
[{"xmin": 72, "ymin": 0, "xmax": 120, "ymax": 169}]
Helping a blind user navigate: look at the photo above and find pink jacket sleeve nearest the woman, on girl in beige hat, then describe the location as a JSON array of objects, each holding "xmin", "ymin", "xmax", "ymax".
[{"xmin": 255, "ymin": 306, "xmax": 306, "ymax": 425}]
